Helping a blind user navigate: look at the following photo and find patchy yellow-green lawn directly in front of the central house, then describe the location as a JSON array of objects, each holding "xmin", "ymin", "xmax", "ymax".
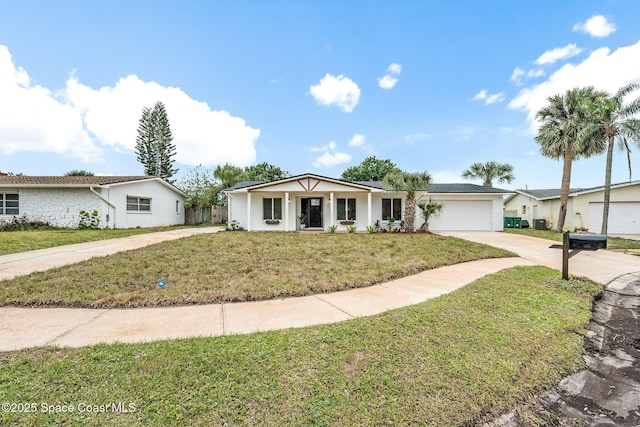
[{"xmin": 0, "ymin": 232, "xmax": 514, "ymax": 308}]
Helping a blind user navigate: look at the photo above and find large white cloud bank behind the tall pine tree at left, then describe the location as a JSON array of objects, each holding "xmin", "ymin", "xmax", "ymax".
[{"xmin": 0, "ymin": 45, "xmax": 260, "ymax": 166}]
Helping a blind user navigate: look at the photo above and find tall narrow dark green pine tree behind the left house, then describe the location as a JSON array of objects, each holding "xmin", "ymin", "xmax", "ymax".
[{"xmin": 135, "ymin": 102, "xmax": 178, "ymax": 182}]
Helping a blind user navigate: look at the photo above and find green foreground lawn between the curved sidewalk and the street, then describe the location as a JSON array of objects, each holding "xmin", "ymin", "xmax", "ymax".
[{"xmin": 0, "ymin": 266, "xmax": 602, "ymax": 426}]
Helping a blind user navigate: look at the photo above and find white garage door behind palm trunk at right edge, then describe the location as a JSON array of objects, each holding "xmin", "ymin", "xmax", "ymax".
[{"xmin": 589, "ymin": 202, "xmax": 640, "ymax": 234}]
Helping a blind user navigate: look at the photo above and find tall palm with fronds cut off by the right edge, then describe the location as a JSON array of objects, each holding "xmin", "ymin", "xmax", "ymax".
[{"xmin": 588, "ymin": 83, "xmax": 640, "ymax": 234}]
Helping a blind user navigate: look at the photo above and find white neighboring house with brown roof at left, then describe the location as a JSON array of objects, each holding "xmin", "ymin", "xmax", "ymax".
[{"xmin": 0, "ymin": 175, "xmax": 185, "ymax": 228}]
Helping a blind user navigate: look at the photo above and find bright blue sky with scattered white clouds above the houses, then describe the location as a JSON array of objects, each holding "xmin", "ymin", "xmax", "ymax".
[{"xmin": 0, "ymin": 0, "xmax": 640, "ymax": 189}]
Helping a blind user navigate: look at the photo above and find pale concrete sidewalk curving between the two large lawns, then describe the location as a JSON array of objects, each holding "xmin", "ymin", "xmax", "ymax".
[{"xmin": 0, "ymin": 258, "xmax": 530, "ymax": 351}]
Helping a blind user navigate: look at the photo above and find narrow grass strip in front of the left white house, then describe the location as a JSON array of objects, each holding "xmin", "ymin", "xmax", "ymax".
[{"xmin": 0, "ymin": 227, "xmax": 204, "ymax": 255}]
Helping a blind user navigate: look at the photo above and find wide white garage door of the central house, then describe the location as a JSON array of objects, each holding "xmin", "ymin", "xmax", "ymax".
[{"xmin": 429, "ymin": 200, "xmax": 493, "ymax": 231}]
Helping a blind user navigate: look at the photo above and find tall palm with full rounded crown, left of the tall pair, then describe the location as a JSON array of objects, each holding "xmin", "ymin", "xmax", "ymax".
[{"xmin": 535, "ymin": 86, "xmax": 606, "ymax": 233}]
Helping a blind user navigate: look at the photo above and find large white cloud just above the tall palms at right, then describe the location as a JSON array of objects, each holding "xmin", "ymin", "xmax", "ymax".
[{"xmin": 508, "ymin": 41, "xmax": 640, "ymax": 132}]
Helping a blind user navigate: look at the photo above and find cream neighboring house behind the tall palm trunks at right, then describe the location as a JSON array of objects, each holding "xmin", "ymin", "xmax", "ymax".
[{"xmin": 505, "ymin": 181, "xmax": 640, "ymax": 234}]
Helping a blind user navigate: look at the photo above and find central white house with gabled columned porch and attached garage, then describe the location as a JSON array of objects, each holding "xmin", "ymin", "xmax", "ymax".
[{"xmin": 225, "ymin": 174, "xmax": 511, "ymax": 231}]
